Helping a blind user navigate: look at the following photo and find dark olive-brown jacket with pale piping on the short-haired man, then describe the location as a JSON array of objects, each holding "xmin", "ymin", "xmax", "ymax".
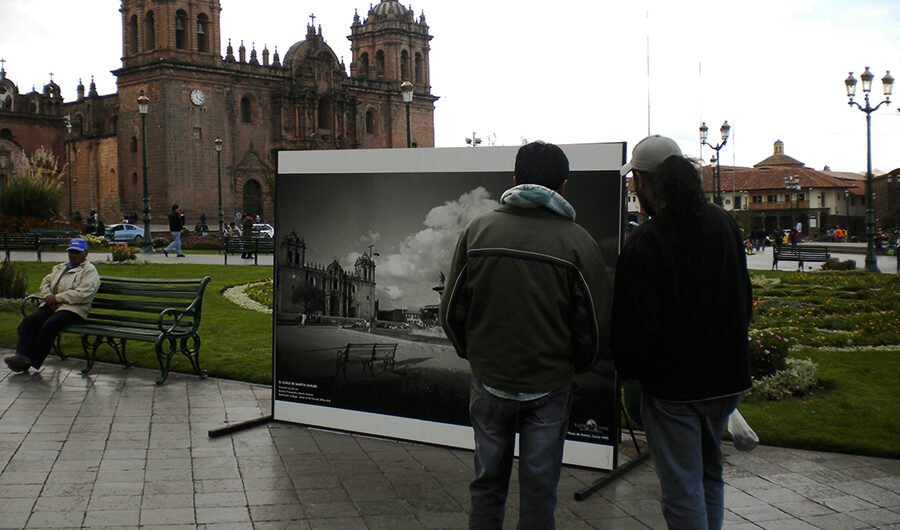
[{"xmin": 440, "ymin": 205, "xmax": 612, "ymax": 392}]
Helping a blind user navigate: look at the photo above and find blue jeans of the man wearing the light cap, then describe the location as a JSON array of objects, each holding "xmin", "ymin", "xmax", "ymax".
[{"xmin": 641, "ymin": 391, "xmax": 739, "ymax": 530}]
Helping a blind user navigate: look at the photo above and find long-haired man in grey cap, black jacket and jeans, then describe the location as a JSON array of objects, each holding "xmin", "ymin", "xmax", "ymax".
[{"xmin": 611, "ymin": 136, "xmax": 753, "ymax": 529}]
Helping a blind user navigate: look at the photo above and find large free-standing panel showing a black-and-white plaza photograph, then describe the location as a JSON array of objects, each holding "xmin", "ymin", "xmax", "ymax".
[{"xmin": 273, "ymin": 143, "xmax": 625, "ymax": 469}]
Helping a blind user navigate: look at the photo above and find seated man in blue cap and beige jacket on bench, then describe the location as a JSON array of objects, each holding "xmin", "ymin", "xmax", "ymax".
[{"xmin": 3, "ymin": 238, "xmax": 100, "ymax": 372}]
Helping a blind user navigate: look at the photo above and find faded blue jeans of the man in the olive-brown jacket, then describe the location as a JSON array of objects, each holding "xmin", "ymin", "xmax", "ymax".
[{"xmin": 469, "ymin": 378, "xmax": 572, "ymax": 530}]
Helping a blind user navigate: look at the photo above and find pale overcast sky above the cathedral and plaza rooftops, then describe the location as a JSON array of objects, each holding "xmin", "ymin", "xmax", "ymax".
[{"xmin": 0, "ymin": 0, "xmax": 900, "ymax": 173}]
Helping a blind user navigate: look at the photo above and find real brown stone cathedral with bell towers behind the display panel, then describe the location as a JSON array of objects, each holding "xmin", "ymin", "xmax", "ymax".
[{"xmin": 0, "ymin": 0, "xmax": 438, "ymax": 226}]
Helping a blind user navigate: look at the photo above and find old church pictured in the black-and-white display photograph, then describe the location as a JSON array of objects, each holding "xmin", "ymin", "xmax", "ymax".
[{"xmin": 276, "ymin": 231, "xmax": 378, "ymax": 320}]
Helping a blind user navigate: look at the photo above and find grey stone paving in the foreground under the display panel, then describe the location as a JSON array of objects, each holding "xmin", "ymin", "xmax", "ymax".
[{"xmin": 0, "ymin": 349, "xmax": 900, "ymax": 529}]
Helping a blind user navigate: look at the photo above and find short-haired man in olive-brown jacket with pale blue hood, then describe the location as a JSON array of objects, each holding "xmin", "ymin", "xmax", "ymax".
[{"xmin": 439, "ymin": 138, "xmax": 612, "ymax": 529}]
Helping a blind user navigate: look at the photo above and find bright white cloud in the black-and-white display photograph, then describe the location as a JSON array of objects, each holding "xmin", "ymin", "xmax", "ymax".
[{"xmin": 376, "ymin": 186, "xmax": 499, "ymax": 290}]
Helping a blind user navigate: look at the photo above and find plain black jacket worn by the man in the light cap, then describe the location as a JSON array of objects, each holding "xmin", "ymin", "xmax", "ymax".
[{"xmin": 612, "ymin": 204, "xmax": 753, "ymax": 401}]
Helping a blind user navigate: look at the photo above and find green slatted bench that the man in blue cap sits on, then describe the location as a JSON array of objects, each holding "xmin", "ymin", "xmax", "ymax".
[{"xmin": 22, "ymin": 276, "xmax": 210, "ymax": 385}]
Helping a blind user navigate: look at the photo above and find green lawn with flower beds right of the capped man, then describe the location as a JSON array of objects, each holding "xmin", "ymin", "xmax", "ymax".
[{"xmin": 739, "ymin": 272, "xmax": 900, "ymax": 458}]
